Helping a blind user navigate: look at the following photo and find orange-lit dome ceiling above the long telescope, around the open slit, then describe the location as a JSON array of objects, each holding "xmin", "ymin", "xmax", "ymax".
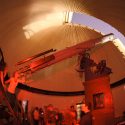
[{"xmin": 0, "ymin": 0, "xmax": 125, "ymax": 89}]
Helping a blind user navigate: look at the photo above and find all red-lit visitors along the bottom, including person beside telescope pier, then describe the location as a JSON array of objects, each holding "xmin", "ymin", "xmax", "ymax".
[{"xmin": 32, "ymin": 104, "xmax": 92, "ymax": 125}]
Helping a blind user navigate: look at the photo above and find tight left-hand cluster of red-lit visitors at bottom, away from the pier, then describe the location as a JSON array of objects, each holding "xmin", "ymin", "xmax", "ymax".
[{"xmin": 32, "ymin": 104, "xmax": 63, "ymax": 125}]
